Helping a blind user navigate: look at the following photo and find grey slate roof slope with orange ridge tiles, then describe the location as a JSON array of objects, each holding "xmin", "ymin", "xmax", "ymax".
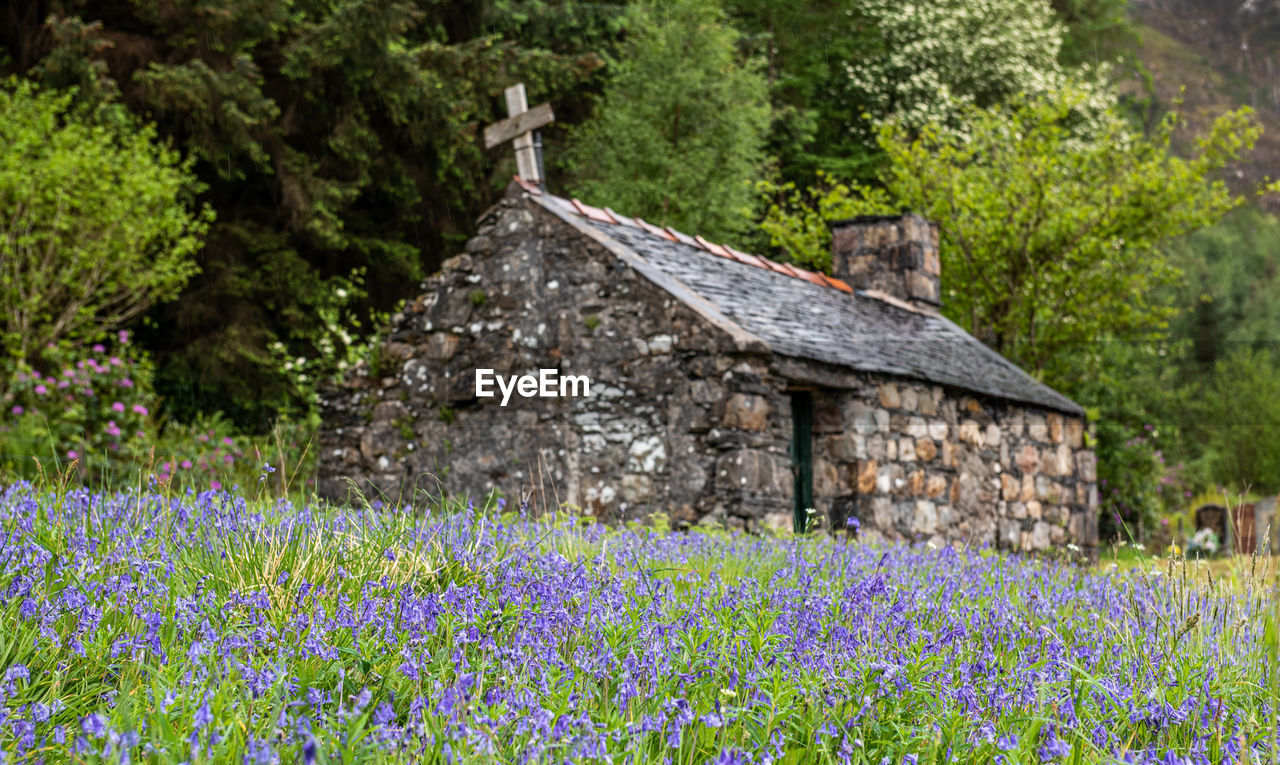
[{"xmin": 521, "ymin": 177, "xmax": 1084, "ymax": 416}]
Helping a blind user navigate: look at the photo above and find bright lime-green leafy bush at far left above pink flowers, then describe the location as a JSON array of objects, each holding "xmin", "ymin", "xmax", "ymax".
[{"xmin": 0, "ymin": 79, "xmax": 212, "ymax": 358}]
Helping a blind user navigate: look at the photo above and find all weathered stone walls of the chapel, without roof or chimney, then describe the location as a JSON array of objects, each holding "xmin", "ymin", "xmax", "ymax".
[{"xmin": 321, "ymin": 188, "xmax": 1097, "ymax": 557}]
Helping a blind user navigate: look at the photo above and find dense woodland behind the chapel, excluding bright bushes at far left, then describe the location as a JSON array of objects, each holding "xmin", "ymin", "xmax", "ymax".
[{"xmin": 0, "ymin": 0, "xmax": 1280, "ymax": 542}]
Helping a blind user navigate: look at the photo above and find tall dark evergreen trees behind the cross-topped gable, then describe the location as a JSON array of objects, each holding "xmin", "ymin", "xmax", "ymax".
[{"xmin": 0, "ymin": 0, "xmax": 609, "ymax": 430}]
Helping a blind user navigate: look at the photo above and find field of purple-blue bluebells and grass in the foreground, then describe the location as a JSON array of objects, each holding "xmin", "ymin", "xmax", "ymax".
[{"xmin": 0, "ymin": 482, "xmax": 1280, "ymax": 765}]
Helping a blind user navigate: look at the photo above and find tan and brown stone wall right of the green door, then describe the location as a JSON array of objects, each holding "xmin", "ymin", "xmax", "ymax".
[{"xmin": 813, "ymin": 377, "xmax": 1097, "ymax": 550}]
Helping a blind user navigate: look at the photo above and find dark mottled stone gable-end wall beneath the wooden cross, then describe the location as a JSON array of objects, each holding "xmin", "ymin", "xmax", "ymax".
[{"xmin": 320, "ymin": 189, "xmax": 791, "ymax": 528}]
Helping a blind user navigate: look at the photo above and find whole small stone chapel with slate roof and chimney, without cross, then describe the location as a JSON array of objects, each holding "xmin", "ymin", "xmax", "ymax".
[{"xmin": 320, "ymin": 179, "xmax": 1097, "ymax": 551}]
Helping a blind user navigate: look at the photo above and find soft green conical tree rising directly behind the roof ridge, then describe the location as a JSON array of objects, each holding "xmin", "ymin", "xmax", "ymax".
[{"xmin": 568, "ymin": 0, "xmax": 769, "ymax": 238}]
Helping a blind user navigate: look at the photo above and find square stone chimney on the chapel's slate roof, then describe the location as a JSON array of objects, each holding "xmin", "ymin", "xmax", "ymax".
[{"xmin": 831, "ymin": 212, "xmax": 942, "ymax": 313}]
